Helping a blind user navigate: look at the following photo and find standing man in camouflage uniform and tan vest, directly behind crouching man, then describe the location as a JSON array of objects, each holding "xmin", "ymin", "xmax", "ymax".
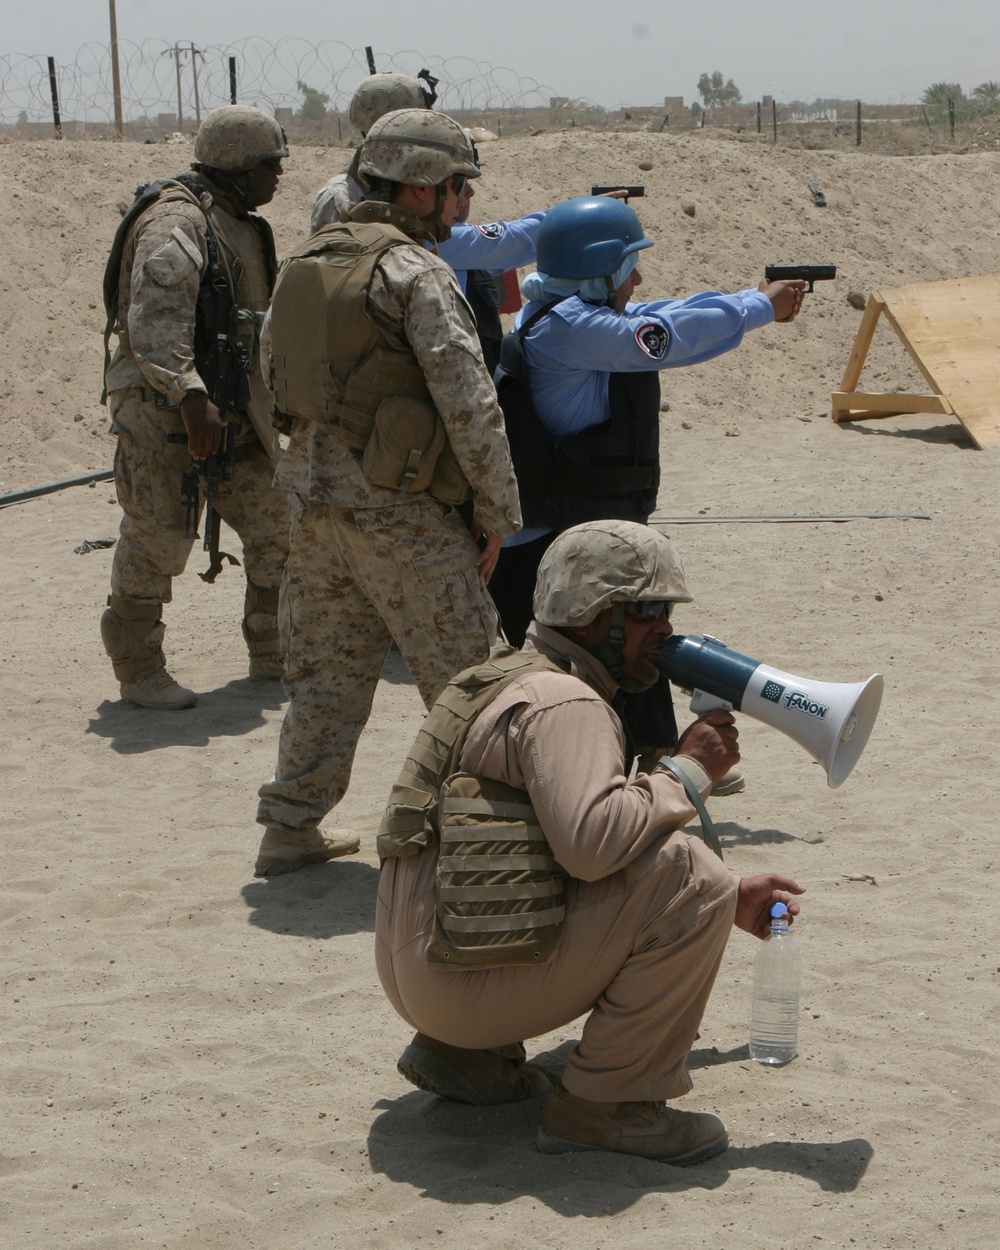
[{"xmin": 255, "ymin": 109, "xmax": 521, "ymax": 876}]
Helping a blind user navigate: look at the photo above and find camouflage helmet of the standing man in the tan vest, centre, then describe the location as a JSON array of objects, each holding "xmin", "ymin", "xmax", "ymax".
[{"xmin": 358, "ymin": 109, "xmax": 479, "ymax": 186}]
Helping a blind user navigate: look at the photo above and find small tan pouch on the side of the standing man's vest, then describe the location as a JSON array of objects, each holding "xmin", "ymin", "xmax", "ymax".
[{"xmin": 361, "ymin": 395, "xmax": 448, "ymax": 493}]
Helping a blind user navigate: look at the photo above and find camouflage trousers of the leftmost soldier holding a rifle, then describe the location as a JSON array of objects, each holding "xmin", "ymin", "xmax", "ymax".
[{"xmin": 111, "ymin": 393, "xmax": 289, "ymax": 604}]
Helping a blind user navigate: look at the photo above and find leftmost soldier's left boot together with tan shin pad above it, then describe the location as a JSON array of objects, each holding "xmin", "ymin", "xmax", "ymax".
[{"xmin": 101, "ymin": 595, "xmax": 198, "ymax": 711}]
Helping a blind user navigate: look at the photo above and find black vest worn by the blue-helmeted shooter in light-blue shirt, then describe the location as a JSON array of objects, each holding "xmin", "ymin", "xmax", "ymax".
[{"xmin": 496, "ymin": 300, "xmax": 660, "ymax": 530}]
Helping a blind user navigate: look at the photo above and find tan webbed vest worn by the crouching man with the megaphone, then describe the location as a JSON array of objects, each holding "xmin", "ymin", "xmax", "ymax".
[{"xmin": 378, "ymin": 645, "xmax": 566, "ymax": 969}]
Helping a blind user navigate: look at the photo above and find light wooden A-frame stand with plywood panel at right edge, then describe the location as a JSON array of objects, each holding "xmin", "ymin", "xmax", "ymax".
[{"xmin": 831, "ymin": 274, "xmax": 1000, "ymax": 449}]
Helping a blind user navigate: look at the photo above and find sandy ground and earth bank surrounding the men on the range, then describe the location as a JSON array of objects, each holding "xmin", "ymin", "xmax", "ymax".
[{"xmin": 0, "ymin": 134, "xmax": 1000, "ymax": 1250}]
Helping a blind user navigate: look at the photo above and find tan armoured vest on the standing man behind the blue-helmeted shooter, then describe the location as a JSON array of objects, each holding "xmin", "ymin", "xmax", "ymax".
[{"xmin": 263, "ymin": 221, "xmax": 473, "ymax": 504}]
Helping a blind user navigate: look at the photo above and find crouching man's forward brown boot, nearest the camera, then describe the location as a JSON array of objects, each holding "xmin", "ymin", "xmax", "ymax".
[{"xmin": 536, "ymin": 1085, "xmax": 729, "ymax": 1168}]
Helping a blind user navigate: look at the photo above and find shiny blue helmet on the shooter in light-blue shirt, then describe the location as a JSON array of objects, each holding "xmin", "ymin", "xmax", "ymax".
[{"xmin": 538, "ymin": 195, "xmax": 653, "ymax": 279}]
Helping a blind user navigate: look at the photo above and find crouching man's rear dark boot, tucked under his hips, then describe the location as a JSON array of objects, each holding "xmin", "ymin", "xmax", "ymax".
[{"xmin": 396, "ymin": 1033, "xmax": 551, "ymax": 1106}]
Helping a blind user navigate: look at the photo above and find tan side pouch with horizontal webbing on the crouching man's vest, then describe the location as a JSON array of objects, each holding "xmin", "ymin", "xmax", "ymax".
[{"xmin": 428, "ymin": 773, "xmax": 566, "ymax": 969}]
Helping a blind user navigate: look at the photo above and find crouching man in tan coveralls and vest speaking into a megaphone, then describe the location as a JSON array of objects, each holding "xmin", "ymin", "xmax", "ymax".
[{"xmin": 375, "ymin": 521, "xmax": 803, "ymax": 1165}]
